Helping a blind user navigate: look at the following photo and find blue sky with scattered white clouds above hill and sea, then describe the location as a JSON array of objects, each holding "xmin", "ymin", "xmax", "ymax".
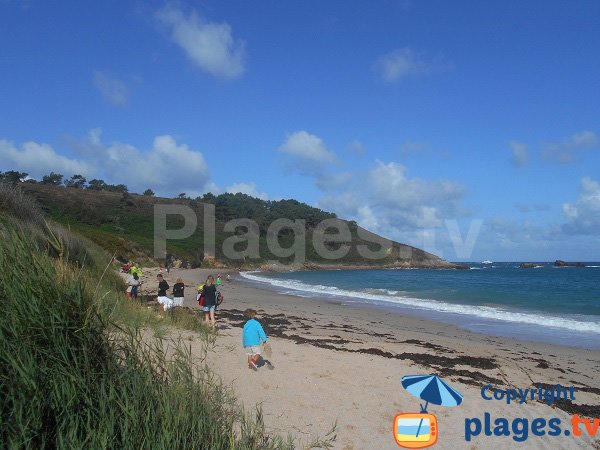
[{"xmin": 0, "ymin": 0, "xmax": 600, "ymax": 261}]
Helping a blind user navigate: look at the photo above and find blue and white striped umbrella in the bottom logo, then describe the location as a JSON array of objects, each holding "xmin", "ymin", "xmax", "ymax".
[{"xmin": 402, "ymin": 375, "xmax": 463, "ymax": 436}]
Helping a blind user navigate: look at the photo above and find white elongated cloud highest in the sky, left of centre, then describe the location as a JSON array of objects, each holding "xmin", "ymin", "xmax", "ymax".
[{"xmin": 156, "ymin": 5, "xmax": 246, "ymax": 79}]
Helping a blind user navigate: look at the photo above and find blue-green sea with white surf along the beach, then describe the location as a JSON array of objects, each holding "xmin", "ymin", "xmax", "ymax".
[{"xmin": 242, "ymin": 263, "xmax": 600, "ymax": 349}]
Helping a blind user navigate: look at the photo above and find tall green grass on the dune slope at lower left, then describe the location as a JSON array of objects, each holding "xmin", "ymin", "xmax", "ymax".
[{"xmin": 0, "ymin": 220, "xmax": 334, "ymax": 449}]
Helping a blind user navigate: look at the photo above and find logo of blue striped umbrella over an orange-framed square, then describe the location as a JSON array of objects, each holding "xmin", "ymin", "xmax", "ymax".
[{"xmin": 393, "ymin": 375, "xmax": 463, "ymax": 448}]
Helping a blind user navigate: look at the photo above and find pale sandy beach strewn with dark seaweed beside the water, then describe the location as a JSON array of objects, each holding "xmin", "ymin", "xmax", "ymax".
[{"xmin": 134, "ymin": 269, "xmax": 600, "ymax": 450}]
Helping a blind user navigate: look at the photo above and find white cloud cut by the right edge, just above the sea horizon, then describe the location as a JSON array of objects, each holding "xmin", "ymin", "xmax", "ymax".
[{"xmin": 562, "ymin": 177, "xmax": 600, "ymax": 235}]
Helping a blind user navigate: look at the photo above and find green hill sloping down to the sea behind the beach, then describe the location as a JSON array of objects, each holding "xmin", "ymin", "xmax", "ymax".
[{"xmin": 19, "ymin": 183, "xmax": 456, "ymax": 268}]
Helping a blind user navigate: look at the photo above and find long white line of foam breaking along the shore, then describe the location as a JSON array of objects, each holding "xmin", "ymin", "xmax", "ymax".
[{"xmin": 240, "ymin": 272, "xmax": 600, "ymax": 334}]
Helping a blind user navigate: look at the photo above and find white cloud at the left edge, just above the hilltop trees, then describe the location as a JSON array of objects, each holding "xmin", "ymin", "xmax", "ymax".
[{"xmin": 0, "ymin": 139, "xmax": 94, "ymax": 179}]
